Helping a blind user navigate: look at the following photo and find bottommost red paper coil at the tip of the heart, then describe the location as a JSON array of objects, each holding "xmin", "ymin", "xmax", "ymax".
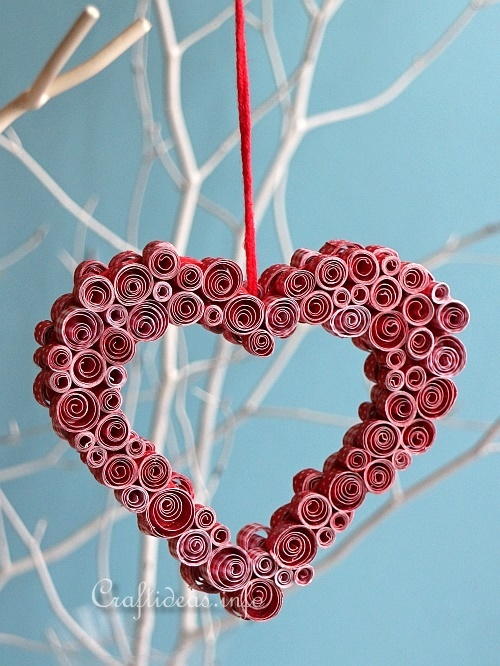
[{"xmin": 222, "ymin": 578, "xmax": 283, "ymax": 622}]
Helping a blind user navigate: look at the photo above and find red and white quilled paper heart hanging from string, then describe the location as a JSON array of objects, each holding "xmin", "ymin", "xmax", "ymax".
[{"xmin": 33, "ymin": 240, "xmax": 469, "ymax": 620}]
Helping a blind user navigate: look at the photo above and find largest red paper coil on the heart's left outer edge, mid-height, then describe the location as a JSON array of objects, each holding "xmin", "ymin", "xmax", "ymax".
[{"xmin": 50, "ymin": 388, "xmax": 99, "ymax": 433}]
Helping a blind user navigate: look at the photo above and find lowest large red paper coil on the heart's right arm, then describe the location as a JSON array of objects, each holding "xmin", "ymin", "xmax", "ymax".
[{"xmin": 266, "ymin": 523, "xmax": 318, "ymax": 568}]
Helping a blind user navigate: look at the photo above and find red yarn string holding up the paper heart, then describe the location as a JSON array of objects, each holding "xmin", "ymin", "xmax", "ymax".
[{"xmin": 234, "ymin": 0, "xmax": 258, "ymax": 295}]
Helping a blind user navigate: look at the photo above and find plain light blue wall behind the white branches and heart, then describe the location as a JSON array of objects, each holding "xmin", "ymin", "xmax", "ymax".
[{"xmin": 0, "ymin": 0, "xmax": 500, "ymax": 666}]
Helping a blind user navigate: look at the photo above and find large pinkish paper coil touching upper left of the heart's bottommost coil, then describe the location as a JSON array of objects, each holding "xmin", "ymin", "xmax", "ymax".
[{"xmin": 201, "ymin": 545, "xmax": 252, "ymax": 591}]
